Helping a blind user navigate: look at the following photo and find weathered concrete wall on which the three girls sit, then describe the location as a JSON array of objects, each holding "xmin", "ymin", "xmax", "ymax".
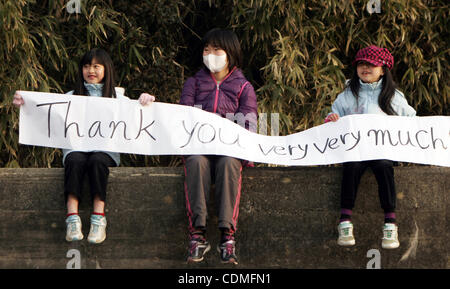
[{"xmin": 0, "ymin": 166, "xmax": 450, "ymax": 269}]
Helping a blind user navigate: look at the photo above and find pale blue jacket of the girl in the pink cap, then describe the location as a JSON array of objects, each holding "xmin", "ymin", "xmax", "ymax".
[{"xmin": 331, "ymin": 79, "xmax": 416, "ymax": 117}]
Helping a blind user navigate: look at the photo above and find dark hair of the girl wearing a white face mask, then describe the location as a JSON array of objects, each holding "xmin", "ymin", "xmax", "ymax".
[{"xmin": 202, "ymin": 28, "xmax": 243, "ymax": 70}]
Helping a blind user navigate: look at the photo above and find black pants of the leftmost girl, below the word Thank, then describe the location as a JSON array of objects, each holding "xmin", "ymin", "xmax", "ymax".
[{"xmin": 64, "ymin": 152, "xmax": 116, "ymax": 203}]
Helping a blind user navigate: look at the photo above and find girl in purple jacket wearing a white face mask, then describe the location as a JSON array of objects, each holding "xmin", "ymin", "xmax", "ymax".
[{"xmin": 180, "ymin": 29, "xmax": 257, "ymax": 264}]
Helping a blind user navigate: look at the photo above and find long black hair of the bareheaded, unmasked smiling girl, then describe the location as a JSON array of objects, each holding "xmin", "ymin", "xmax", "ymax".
[{"xmin": 74, "ymin": 48, "xmax": 117, "ymax": 98}]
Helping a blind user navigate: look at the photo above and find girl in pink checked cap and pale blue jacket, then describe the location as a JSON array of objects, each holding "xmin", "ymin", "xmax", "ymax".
[{"xmin": 325, "ymin": 45, "xmax": 416, "ymax": 249}]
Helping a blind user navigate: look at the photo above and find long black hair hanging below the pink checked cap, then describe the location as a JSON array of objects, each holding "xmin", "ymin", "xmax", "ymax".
[{"xmin": 347, "ymin": 65, "xmax": 397, "ymax": 115}]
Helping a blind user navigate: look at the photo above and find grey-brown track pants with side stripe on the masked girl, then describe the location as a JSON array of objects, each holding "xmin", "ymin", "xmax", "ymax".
[{"xmin": 184, "ymin": 155, "xmax": 242, "ymax": 233}]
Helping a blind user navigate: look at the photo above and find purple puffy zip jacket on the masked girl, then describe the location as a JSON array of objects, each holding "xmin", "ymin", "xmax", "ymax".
[{"xmin": 180, "ymin": 68, "xmax": 258, "ymax": 132}]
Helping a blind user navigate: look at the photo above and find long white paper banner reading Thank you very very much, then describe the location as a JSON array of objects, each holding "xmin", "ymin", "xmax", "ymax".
[{"xmin": 19, "ymin": 91, "xmax": 450, "ymax": 167}]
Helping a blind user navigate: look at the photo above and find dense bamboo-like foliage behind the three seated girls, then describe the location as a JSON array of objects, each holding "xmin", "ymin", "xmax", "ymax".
[{"xmin": 0, "ymin": 0, "xmax": 450, "ymax": 167}]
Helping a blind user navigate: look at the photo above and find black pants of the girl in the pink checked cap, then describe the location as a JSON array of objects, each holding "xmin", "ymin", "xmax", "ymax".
[{"xmin": 341, "ymin": 160, "xmax": 396, "ymax": 213}]
